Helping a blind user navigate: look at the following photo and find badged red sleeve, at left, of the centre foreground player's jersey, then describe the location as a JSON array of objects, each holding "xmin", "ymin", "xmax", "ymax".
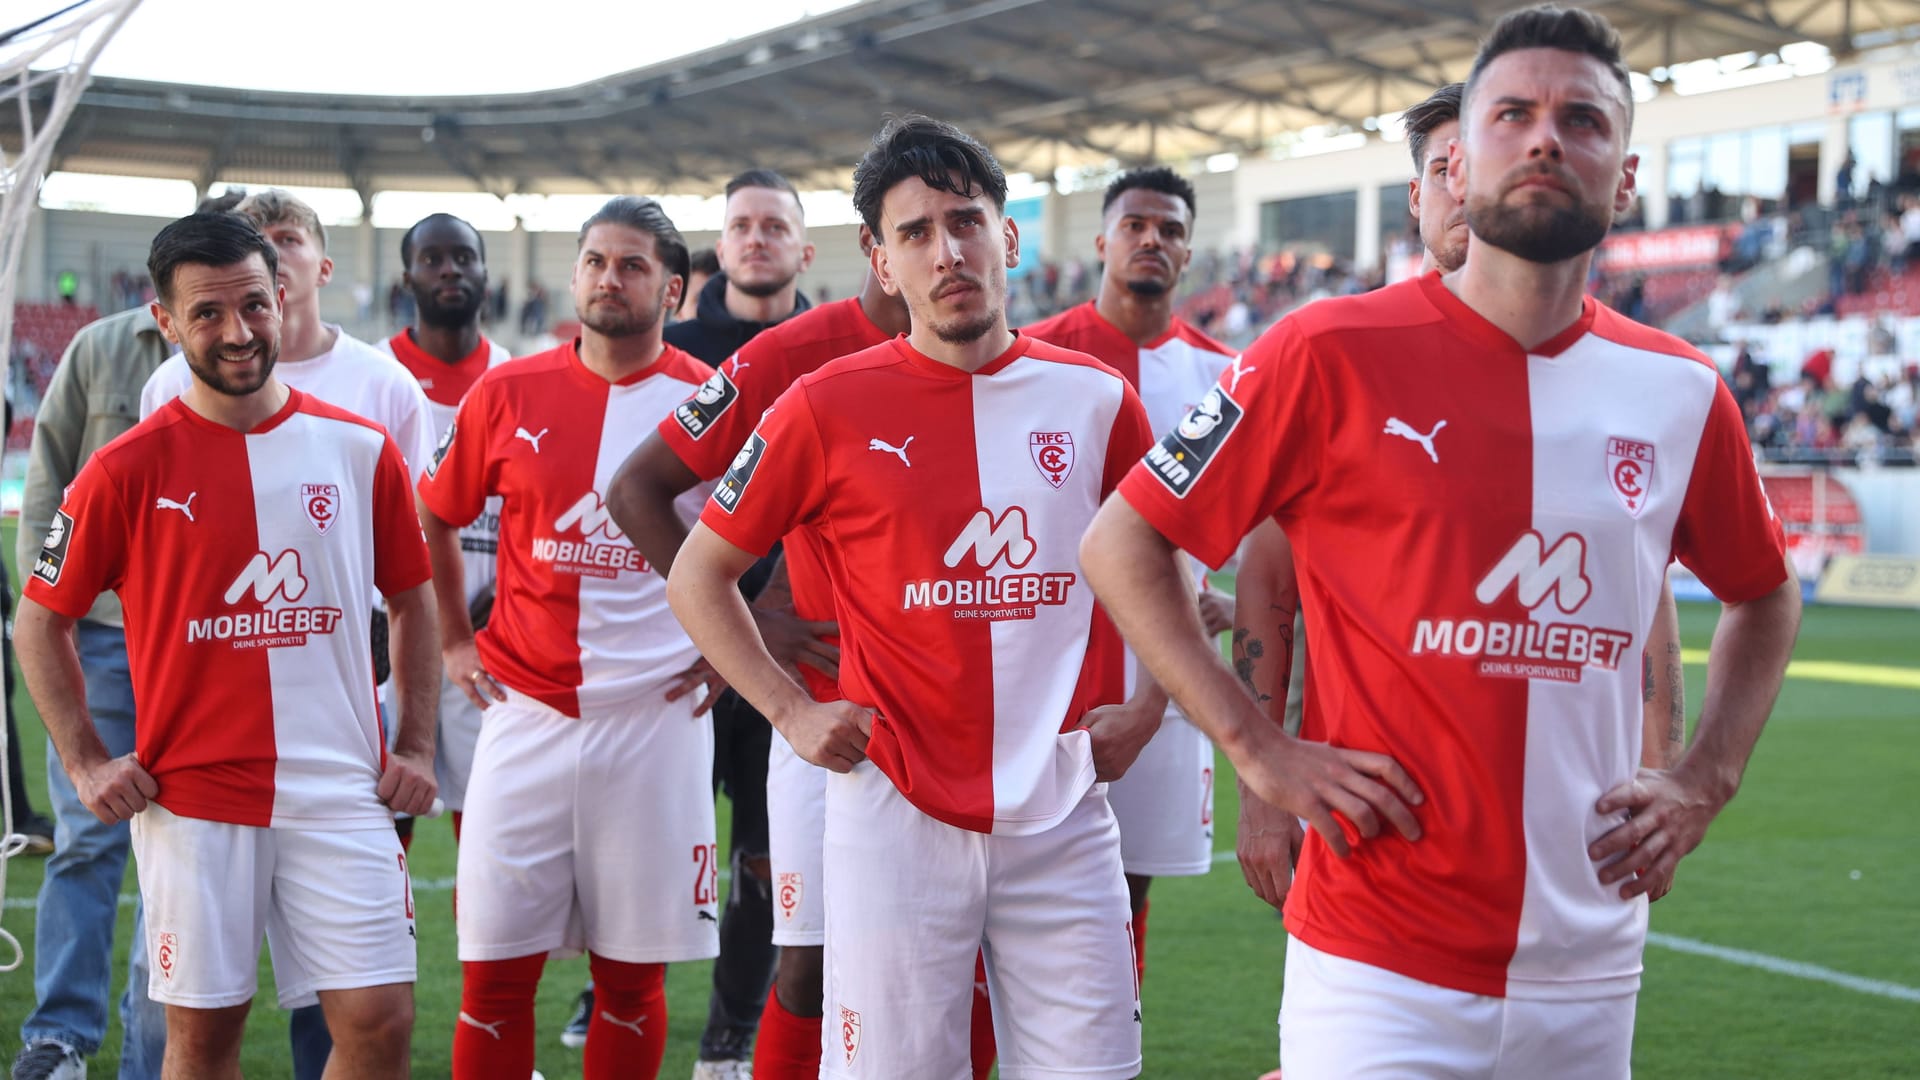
[{"xmin": 701, "ymin": 384, "xmax": 826, "ymax": 555}]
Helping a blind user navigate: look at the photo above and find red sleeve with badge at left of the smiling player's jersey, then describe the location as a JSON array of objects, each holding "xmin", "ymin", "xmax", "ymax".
[{"xmin": 25, "ymin": 457, "xmax": 129, "ymax": 619}]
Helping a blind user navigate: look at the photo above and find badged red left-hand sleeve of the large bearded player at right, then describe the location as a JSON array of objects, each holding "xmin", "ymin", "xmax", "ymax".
[{"xmin": 1119, "ymin": 319, "xmax": 1327, "ymax": 569}]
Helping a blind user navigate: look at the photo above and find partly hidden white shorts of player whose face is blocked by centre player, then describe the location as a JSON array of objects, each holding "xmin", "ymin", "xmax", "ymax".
[{"xmin": 766, "ymin": 730, "xmax": 831, "ymax": 945}]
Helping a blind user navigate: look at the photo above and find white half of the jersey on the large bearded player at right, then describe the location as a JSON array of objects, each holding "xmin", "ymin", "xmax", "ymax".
[{"xmin": 1507, "ymin": 334, "xmax": 1715, "ymax": 997}]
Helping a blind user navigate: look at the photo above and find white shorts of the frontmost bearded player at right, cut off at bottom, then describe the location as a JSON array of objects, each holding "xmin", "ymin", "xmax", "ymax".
[{"xmin": 1281, "ymin": 936, "xmax": 1638, "ymax": 1080}]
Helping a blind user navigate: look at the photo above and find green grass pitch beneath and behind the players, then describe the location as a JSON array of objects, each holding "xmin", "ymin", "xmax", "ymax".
[{"xmin": 0, "ymin": 523, "xmax": 1920, "ymax": 1080}]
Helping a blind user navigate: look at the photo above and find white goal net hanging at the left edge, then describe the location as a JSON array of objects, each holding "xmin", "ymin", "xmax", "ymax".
[{"xmin": 0, "ymin": 0, "xmax": 140, "ymax": 972}]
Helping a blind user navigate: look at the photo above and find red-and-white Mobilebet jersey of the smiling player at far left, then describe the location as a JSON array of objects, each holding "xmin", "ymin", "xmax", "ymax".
[{"xmin": 27, "ymin": 390, "xmax": 430, "ymax": 828}]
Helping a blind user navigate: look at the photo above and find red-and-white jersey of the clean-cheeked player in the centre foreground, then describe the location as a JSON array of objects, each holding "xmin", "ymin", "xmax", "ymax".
[{"xmin": 701, "ymin": 336, "xmax": 1152, "ymax": 834}]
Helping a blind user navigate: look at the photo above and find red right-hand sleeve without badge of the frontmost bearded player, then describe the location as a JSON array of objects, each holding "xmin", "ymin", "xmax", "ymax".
[{"xmin": 1674, "ymin": 379, "xmax": 1788, "ymax": 603}]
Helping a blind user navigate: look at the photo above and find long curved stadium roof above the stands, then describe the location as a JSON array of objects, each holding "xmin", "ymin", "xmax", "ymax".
[{"xmin": 15, "ymin": 0, "xmax": 1920, "ymax": 196}]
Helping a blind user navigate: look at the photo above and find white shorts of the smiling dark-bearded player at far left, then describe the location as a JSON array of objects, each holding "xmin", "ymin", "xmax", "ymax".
[{"xmin": 132, "ymin": 803, "xmax": 415, "ymax": 1009}]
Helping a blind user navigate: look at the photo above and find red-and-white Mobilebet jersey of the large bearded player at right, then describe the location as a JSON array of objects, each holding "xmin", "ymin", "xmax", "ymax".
[{"xmin": 1119, "ymin": 275, "xmax": 1786, "ymax": 997}]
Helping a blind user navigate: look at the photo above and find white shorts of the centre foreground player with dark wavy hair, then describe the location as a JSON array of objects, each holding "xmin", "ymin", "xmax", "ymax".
[{"xmin": 821, "ymin": 761, "xmax": 1140, "ymax": 1080}]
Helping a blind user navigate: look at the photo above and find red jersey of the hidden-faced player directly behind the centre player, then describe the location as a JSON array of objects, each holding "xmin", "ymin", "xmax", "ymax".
[{"xmin": 660, "ymin": 296, "xmax": 887, "ymax": 701}]
